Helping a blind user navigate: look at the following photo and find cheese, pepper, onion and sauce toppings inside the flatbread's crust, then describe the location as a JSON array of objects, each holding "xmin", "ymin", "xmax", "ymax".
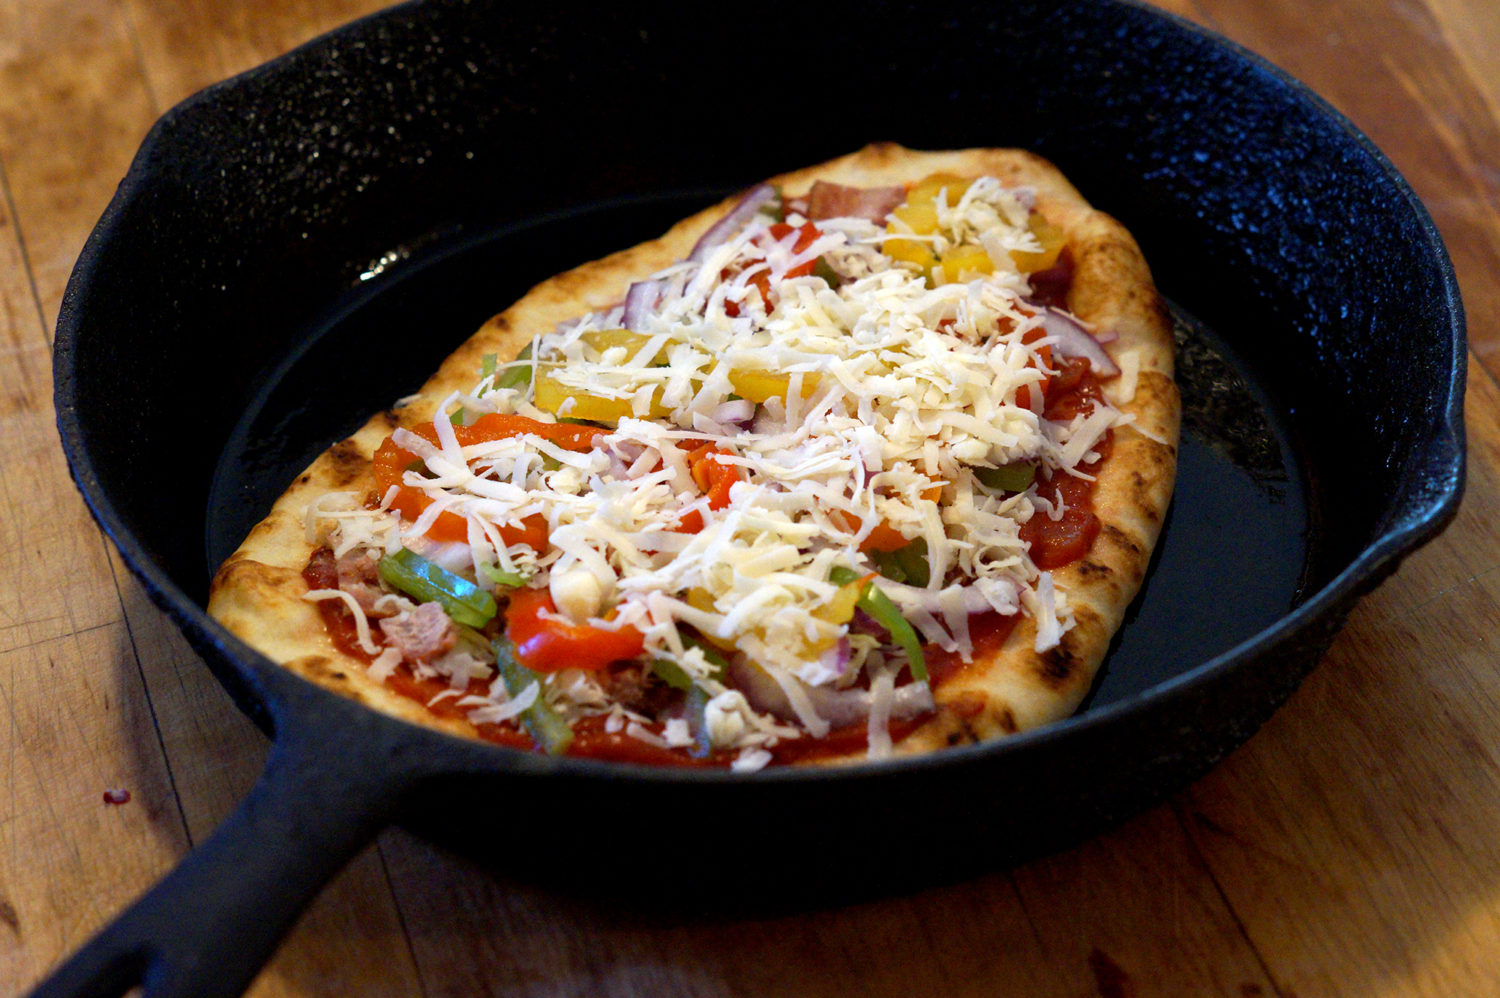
[{"xmin": 309, "ymin": 174, "xmax": 1125, "ymax": 768}]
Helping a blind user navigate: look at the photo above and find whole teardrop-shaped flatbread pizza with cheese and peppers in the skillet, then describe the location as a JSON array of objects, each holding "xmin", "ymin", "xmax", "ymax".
[{"xmin": 209, "ymin": 144, "xmax": 1179, "ymax": 770}]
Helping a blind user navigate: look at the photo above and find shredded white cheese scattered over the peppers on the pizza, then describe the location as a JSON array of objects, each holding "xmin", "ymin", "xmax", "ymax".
[{"xmin": 309, "ymin": 179, "xmax": 1122, "ymax": 768}]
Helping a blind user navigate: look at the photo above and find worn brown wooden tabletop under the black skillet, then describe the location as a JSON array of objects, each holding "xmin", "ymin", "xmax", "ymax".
[{"xmin": 0, "ymin": 0, "xmax": 1500, "ymax": 998}]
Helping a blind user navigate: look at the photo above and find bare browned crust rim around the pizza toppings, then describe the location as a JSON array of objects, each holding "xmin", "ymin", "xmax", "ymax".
[{"xmin": 209, "ymin": 144, "xmax": 1179, "ymax": 762}]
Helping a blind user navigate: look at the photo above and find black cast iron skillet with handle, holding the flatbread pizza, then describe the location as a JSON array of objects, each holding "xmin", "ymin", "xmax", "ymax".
[{"xmin": 39, "ymin": 0, "xmax": 1466, "ymax": 996}]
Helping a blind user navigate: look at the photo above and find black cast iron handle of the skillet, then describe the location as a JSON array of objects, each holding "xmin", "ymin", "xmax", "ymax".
[{"xmin": 33, "ymin": 719, "xmax": 413, "ymax": 998}]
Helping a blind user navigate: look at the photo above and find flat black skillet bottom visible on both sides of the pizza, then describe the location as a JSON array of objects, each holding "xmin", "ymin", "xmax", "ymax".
[{"xmin": 204, "ymin": 191, "xmax": 1311, "ymax": 705}]
